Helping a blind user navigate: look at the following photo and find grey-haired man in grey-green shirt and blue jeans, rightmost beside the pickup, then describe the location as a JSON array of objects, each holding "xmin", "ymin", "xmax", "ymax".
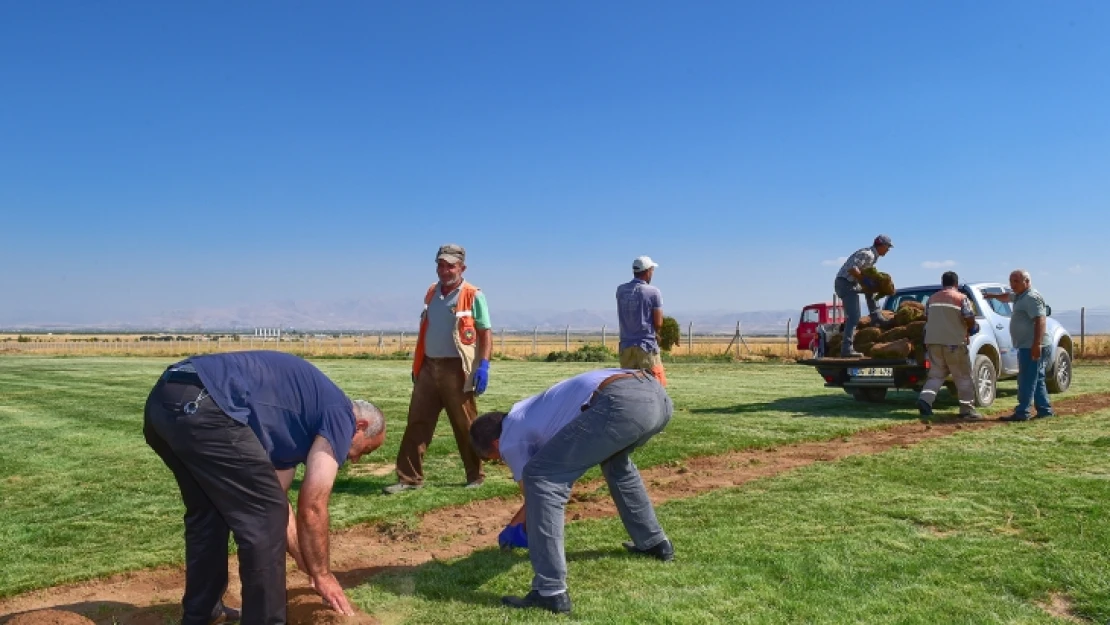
[{"xmin": 983, "ymin": 269, "xmax": 1056, "ymax": 421}]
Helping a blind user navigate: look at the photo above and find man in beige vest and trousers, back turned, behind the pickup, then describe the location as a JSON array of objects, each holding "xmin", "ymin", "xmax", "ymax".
[{"xmin": 917, "ymin": 271, "xmax": 982, "ymax": 420}]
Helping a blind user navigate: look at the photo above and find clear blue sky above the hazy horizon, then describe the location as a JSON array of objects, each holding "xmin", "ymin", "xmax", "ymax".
[{"xmin": 0, "ymin": 0, "xmax": 1110, "ymax": 328}]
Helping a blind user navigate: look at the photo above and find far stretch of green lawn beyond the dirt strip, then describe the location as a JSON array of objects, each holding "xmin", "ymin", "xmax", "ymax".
[{"xmin": 0, "ymin": 356, "xmax": 1110, "ymax": 616}]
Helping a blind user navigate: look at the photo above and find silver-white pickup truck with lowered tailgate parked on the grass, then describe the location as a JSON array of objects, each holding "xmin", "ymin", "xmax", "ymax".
[{"xmin": 799, "ymin": 282, "xmax": 1073, "ymax": 406}]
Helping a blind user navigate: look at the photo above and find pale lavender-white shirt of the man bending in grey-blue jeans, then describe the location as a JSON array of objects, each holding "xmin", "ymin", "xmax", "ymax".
[{"xmin": 498, "ymin": 369, "xmax": 625, "ymax": 482}]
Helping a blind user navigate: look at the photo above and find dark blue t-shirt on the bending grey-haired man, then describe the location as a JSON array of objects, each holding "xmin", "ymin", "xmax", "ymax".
[{"xmin": 188, "ymin": 352, "xmax": 354, "ymax": 468}]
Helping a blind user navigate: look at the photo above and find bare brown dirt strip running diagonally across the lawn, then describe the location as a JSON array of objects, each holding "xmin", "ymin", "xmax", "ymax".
[{"xmin": 0, "ymin": 393, "xmax": 1110, "ymax": 625}]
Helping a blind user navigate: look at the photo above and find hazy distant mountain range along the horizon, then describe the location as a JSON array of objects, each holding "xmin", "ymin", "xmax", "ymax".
[{"xmin": 0, "ymin": 299, "xmax": 1110, "ymax": 335}]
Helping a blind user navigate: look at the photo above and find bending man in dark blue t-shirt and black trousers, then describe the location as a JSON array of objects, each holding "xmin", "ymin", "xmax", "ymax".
[{"xmin": 143, "ymin": 352, "xmax": 385, "ymax": 625}]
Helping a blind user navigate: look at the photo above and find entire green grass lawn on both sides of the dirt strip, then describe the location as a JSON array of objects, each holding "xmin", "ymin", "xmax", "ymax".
[{"xmin": 0, "ymin": 356, "xmax": 1110, "ymax": 623}]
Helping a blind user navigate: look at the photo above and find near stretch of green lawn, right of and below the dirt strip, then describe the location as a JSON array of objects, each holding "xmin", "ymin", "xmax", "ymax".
[{"xmin": 352, "ymin": 411, "xmax": 1110, "ymax": 625}]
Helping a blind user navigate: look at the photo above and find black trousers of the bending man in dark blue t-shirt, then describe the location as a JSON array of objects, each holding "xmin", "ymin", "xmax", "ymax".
[{"xmin": 143, "ymin": 376, "xmax": 289, "ymax": 625}]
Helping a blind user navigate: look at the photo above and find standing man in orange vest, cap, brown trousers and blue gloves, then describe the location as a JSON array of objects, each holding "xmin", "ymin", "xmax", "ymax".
[{"xmin": 383, "ymin": 243, "xmax": 493, "ymax": 495}]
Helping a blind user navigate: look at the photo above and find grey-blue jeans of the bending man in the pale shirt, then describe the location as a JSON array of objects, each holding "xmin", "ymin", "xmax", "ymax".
[{"xmin": 522, "ymin": 376, "xmax": 674, "ymax": 595}]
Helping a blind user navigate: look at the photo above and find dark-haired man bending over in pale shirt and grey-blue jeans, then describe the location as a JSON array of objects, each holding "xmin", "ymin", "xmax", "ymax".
[{"xmin": 471, "ymin": 369, "xmax": 675, "ymax": 613}]
